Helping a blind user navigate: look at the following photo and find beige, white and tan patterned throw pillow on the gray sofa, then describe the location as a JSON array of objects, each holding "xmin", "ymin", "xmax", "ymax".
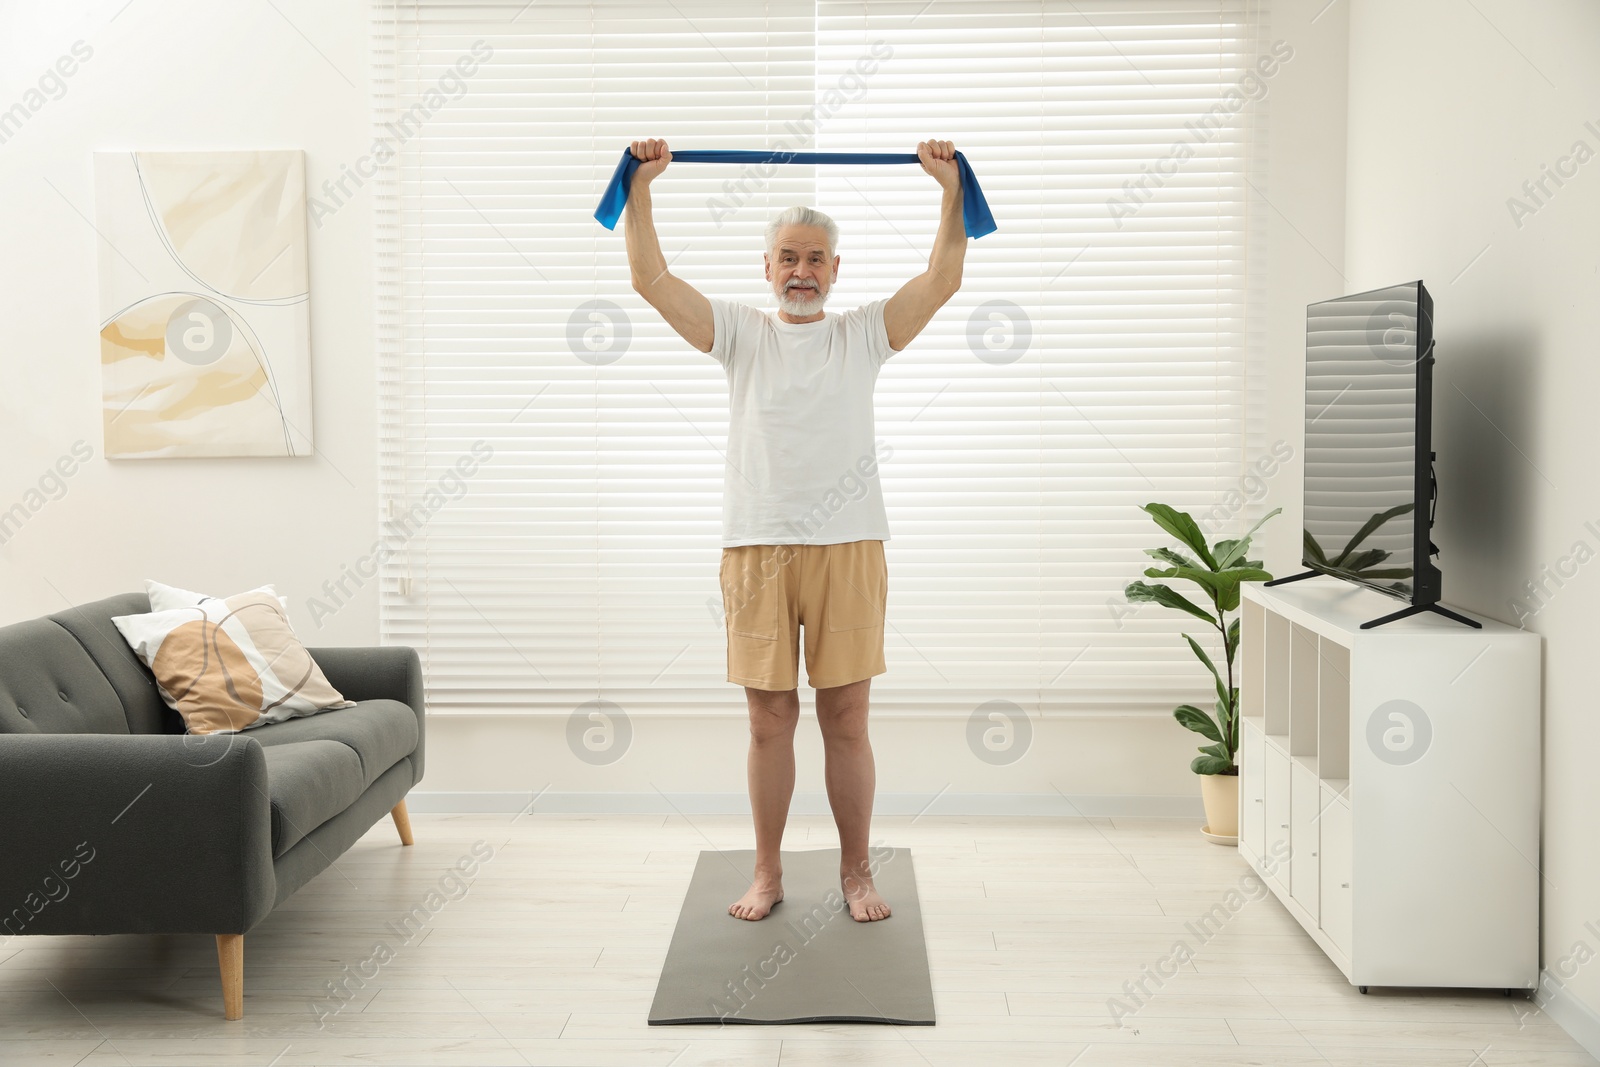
[{"xmin": 112, "ymin": 587, "xmax": 355, "ymax": 734}]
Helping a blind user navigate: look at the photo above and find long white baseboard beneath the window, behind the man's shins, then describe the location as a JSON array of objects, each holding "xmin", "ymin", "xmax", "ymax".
[{"xmin": 406, "ymin": 790, "xmax": 1205, "ymax": 819}]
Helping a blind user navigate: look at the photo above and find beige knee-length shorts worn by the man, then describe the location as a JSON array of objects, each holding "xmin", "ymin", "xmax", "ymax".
[{"xmin": 722, "ymin": 541, "xmax": 888, "ymax": 691}]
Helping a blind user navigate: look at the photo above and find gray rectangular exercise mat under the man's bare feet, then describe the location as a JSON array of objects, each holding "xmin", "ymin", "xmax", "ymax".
[{"xmin": 650, "ymin": 846, "xmax": 934, "ymax": 1025}]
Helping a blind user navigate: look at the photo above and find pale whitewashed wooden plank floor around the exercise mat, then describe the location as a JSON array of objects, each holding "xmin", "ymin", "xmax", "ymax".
[{"xmin": 0, "ymin": 814, "xmax": 1595, "ymax": 1067}]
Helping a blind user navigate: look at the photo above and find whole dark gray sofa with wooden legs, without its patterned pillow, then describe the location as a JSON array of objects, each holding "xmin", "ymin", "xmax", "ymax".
[{"xmin": 0, "ymin": 593, "xmax": 422, "ymax": 1019}]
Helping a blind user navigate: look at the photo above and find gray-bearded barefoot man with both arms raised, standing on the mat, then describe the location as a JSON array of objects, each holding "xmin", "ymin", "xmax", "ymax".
[{"xmin": 624, "ymin": 139, "xmax": 966, "ymax": 923}]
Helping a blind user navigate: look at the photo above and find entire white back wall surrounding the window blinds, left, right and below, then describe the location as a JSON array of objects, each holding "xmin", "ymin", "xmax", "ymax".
[{"xmin": 0, "ymin": 0, "xmax": 1346, "ymax": 811}]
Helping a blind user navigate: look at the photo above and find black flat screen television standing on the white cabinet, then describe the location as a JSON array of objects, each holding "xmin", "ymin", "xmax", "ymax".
[{"xmin": 1267, "ymin": 282, "xmax": 1478, "ymax": 627}]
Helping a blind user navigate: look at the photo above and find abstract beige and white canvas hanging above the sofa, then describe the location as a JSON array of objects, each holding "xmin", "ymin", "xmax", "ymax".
[{"xmin": 94, "ymin": 150, "xmax": 312, "ymax": 459}]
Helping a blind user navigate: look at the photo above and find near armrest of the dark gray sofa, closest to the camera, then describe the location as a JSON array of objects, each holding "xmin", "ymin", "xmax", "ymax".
[{"xmin": 0, "ymin": 734, "xmax": 277, "ymax": 942}]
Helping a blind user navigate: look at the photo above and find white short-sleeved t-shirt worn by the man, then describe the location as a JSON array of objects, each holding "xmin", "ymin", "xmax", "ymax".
[{"xmin": 707, "ymin": 298, "xmax": 894, "ymax": 547}]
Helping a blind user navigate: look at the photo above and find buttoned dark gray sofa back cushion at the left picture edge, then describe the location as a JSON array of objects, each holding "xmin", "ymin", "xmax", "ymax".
[{"xmin": 0, "ymin": 619, "xmax": 128, "ymax": 734}]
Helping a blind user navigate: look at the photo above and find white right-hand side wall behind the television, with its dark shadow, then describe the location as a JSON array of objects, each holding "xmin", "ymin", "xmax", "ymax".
[{"xmin": 1346, "ymin": 0, "xmax": 1600, "ymax": 1051}]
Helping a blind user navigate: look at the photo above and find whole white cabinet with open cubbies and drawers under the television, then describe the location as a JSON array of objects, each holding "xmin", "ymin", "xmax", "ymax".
[{"xmin": 1238, "ymin": 577, "xmax": 1541, "ymax": 989}]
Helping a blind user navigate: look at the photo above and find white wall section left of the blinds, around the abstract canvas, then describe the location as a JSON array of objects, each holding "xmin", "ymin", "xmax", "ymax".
[{"xmin": 0, "ymin": 0, "xmax": 378, "ymax": 645}]
